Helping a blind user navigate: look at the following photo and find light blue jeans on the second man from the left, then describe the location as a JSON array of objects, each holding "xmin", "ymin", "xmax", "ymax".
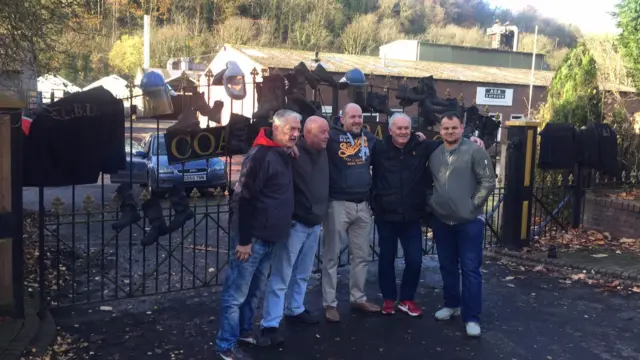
[{"xmin": 262, "ymin": 221, "xmax": 320, "ymax": 328}]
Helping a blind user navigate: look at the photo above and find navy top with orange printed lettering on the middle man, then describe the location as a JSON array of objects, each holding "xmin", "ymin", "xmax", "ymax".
[{"xmin": 327, "ymin": 126, "xmax": 378, "ymax": 202}]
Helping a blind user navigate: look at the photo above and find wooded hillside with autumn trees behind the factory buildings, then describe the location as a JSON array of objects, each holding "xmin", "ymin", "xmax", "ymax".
[{"xmin": 0, "ymin": 0, "xmax": 580, "ymax": 84}]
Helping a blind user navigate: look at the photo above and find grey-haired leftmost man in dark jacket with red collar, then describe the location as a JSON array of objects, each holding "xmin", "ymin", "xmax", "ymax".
[{"xmin": 216, "ymin": 110, "xmax": 301, "ymax": 360}]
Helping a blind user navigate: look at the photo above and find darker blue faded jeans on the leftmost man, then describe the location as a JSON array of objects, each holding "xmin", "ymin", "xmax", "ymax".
[{"xmin": 216, "ymin": 233, "xmax": 274, "ymax": 351}]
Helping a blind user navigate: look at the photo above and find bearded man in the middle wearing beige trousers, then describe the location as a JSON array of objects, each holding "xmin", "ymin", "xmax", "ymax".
[{"xmin": 322, "ymin": 103, "xmax": 380, "ymax": 322}]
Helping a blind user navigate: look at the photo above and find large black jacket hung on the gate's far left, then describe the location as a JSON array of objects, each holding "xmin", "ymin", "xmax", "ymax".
[{"xmin": 23, "ymin": 86, "xmax": 126, "ymax": 186}]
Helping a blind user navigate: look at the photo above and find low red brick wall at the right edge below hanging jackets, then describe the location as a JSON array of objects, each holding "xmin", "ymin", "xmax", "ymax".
[{"xmin": 584, "ymin": 195, "xmax": 640, "ymax": 239}]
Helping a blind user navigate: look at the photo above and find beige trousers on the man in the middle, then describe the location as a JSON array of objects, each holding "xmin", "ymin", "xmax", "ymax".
[{"xmin": 322, "ymin": 200, "xmax": 373, "ymax": 307}]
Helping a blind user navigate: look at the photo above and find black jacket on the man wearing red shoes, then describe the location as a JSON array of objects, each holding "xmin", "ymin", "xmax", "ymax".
[{"xmin": 372, "ymin": 135, "xmax": 442, "ymax": 222}]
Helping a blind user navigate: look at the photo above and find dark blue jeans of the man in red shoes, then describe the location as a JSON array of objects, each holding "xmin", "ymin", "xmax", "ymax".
[{"xmin": 376, "ymin": 219, "xmax": 422, "ymax": 301}]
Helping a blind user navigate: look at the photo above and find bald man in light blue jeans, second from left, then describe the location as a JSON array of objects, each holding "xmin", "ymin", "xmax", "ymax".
[{"xmin": 249, "ymin": 116, "xmax": 329, "ymax": 346}]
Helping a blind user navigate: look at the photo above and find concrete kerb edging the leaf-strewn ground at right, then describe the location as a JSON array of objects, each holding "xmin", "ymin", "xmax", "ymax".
[{"xmin": 485, "ymin": 248, "xmax": 640, "ymax": 284}]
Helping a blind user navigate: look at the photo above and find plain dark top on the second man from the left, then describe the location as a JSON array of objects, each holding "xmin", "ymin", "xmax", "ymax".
[{"xmin": 291, "ymin": 138, "xmax": 329, "ymax": 227}]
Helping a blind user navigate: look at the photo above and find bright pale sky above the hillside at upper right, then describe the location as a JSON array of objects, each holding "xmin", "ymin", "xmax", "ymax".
[{"xmin": 488, "ymin": 0, "xmax": 618, "ymax": 34}]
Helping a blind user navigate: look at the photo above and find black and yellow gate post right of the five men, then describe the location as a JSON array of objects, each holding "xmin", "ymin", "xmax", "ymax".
[{"xmin": 500, "ymin": 121, "xmax": 539, "ymax": 250}]
